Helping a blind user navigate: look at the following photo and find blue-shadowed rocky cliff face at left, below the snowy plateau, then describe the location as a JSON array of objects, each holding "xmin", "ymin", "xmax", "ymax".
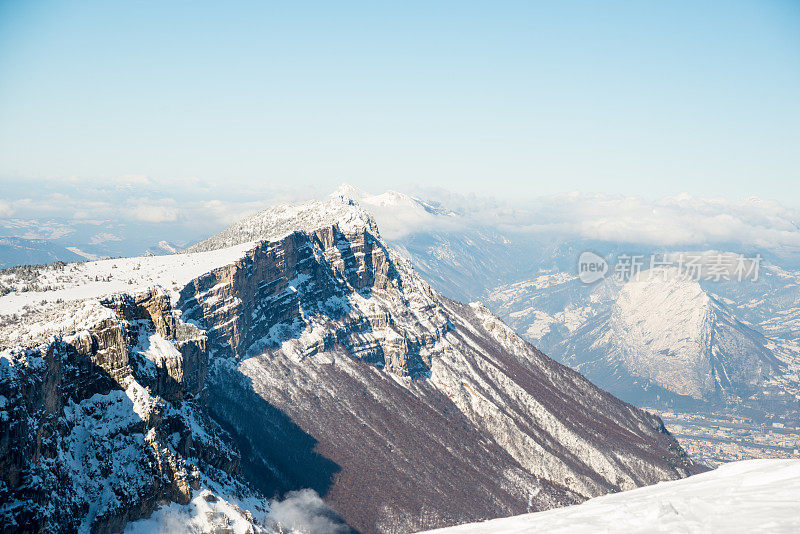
[{"xmin": 0, "ymin": 291, "xmax": 247, "ymax": 532}]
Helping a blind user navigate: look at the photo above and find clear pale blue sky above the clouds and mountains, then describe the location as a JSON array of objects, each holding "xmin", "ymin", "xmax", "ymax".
[{"xmin": 0, "ymin": 0, "xmax": 800, "ymax": 206}]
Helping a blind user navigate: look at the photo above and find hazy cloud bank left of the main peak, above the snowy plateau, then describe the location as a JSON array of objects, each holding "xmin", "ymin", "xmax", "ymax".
[{"xmin": 0, "ymin": 175, "xmax": 312, "ymax": 252}]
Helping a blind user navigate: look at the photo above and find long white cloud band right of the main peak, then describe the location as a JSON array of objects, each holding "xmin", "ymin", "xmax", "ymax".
[{"xmin": 406, "ymin": 192, "xmax": 800, "ymax": 250}]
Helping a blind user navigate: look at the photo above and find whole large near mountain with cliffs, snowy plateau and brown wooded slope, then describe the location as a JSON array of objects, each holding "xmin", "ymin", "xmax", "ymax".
[{"xmin": 0, "ymin": 197, "xmax": 704, "ymax": 533}]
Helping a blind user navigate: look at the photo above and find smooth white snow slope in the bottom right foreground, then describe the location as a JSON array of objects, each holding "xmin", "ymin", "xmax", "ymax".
[{"xmin": 422, "ymin": 460, "xmax": 800, "ymax": 534}]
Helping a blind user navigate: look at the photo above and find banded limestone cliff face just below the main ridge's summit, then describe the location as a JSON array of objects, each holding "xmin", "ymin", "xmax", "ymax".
[{"xmin": 178, "ymin": 225, "xmax": 447, "ymax": 376}]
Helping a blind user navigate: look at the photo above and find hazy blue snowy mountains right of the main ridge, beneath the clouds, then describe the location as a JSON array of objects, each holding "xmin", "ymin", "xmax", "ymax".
[{"xmin": 338, "ymin": 186, "xmax": 800, "ymax": 426}]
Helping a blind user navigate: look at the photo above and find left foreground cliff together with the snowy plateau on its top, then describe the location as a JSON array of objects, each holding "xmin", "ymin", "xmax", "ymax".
[{"xmin": 0, "ymin": 258, "xmax": 280, "ymax": 532}]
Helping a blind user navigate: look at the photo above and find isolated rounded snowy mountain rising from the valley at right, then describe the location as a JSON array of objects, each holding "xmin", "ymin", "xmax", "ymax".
[{"xmin": 563, "ymin": 268, "xmax": 780, "ymax": 400}]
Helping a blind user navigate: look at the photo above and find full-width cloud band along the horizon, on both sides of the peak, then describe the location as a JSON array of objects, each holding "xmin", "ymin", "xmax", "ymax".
[{"xmin": 0, "ymin": 175, "xmax": 800, "ymax": 260}]
